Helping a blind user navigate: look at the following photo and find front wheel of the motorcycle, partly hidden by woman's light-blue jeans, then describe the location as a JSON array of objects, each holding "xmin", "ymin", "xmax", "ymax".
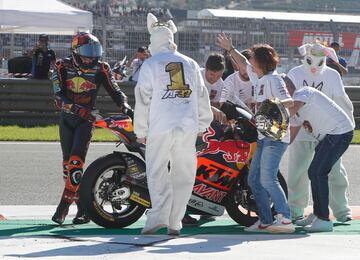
[{"xmin": 225, "ymin": 171, "xmax": 288, "ymax": 227}]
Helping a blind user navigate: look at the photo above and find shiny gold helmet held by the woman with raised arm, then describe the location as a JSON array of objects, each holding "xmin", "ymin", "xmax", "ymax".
[{"xmin": 255, "ymin": 98, "xmax": 289, "ymax": 140}]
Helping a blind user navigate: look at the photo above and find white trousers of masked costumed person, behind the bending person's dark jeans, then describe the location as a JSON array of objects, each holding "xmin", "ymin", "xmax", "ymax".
[{"xmin": 287, "ymin": 141, "xmax": 351, "ymax": 219}]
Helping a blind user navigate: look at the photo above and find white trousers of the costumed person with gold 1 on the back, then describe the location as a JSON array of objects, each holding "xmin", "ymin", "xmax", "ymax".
[{"xmin": 144, "ymin": 128, "xmax": 197, "ymax": 230}]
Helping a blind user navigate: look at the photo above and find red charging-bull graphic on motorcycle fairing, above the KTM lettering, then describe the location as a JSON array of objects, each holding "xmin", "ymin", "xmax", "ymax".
[{"xmin": 197, "ymin": 127, "xmax": 250, "ymax": 163}]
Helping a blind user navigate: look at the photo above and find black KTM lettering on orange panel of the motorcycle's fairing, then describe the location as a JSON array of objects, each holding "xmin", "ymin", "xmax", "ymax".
[{"xmin": 196, "ymin": 157, "xmax": 240, "ymax": 191}]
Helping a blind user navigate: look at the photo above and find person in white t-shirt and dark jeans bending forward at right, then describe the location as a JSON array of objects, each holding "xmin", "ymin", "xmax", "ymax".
[{"xmin": 289, "ymin": 87, "xmax": 354, "ymax": 232}]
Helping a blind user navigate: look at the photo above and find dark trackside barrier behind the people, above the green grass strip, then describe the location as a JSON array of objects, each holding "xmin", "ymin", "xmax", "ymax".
[{"xmin": 0, "ymin": 79, "xmax": 360, "ymax": 129}]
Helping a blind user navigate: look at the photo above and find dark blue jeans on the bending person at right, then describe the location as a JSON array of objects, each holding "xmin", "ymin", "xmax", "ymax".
[{"xmin": 308, "ymin": 131, "xmax": 354, "ymax": 220}]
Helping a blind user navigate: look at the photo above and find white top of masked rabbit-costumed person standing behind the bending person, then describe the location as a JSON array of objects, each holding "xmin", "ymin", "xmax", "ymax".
[{"xmin": 287, "ymin": 65, "xmax": 352, "ymax": 141}]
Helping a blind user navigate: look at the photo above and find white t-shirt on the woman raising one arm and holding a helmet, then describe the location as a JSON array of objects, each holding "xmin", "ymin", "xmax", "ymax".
[{"xmin": 246, "ymin": 65, "xmax": 291, "ymax": 143}]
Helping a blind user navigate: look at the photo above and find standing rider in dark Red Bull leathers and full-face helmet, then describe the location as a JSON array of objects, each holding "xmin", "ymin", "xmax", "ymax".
[{"xmin": 52, "ymin": 33, "xmax": 129, "ymax": 225}]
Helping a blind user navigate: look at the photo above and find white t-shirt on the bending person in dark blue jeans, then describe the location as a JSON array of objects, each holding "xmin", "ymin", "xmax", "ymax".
[{"xmin": 293, "ymin": 87, "xmax": 354, "ymax": 141}]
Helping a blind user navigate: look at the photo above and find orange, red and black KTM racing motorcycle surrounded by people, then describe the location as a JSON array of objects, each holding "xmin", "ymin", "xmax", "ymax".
[{"xmin": 80, "ymin": 102, "xmax": 287, "ymax": 228}]
